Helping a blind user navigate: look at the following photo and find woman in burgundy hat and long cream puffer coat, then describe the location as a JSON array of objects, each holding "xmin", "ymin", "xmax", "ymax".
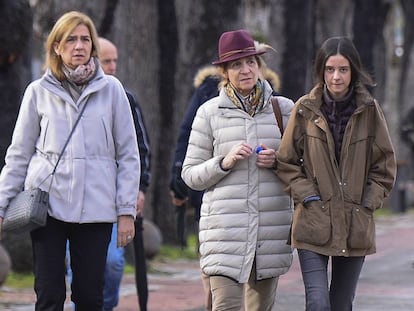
[{"xmin": 182, "ymin": 29, "xmax": 293, "ymax": 311}]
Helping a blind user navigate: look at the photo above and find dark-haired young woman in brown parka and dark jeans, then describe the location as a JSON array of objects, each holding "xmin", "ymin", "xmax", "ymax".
[{"xmin": 278, "ymin": 37, "xmax": 396, "ymax": 311}]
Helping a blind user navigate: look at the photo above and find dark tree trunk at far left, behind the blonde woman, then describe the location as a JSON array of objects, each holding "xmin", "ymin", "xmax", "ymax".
[{"xmin": 0, "ymin": 0, "xmax": 33, "ymax": 271}]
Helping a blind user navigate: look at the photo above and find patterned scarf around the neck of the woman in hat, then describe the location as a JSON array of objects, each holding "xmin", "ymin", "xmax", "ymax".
[{"xmin": 224, "ymin": 80, "xmax": 264, "ymax": 117}]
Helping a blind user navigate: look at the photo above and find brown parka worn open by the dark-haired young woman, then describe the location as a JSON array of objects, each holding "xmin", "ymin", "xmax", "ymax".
[{"xmin": 278, "ymin": 84, "xmax": 396, "ymax": 256}]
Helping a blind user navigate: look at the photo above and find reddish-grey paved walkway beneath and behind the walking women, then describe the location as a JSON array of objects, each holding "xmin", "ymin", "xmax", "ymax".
[{"xmin": 0, "ymin": 211, "xmax": 414, "ymax": 311}]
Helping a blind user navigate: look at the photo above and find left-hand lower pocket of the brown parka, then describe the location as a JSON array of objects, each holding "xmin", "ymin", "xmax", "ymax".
[{"xmin": 292, "ymin": 201, "xmax": 331, "ymax": 246}]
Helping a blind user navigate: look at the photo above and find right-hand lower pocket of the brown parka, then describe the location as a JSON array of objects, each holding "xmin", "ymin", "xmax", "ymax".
[{"xmin": 348, "ymin": 206, "xmax": 375, "ymax": 249}]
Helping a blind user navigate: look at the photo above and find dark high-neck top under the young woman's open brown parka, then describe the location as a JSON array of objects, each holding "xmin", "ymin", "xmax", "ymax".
[{"xmin": 321, "ymin": 86, "xmax": 356, "ymax": 163}]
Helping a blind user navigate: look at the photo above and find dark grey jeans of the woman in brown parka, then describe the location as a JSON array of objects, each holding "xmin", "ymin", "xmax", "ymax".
[{"xmin": 298, "ymin": 249, "xmax": 365, "ymax": 311}]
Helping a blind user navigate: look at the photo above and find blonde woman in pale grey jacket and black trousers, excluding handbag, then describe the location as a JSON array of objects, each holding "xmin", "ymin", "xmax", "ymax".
[{"xmin": 0, "ymin": 11, "xmax": 140, "ymax": 311}]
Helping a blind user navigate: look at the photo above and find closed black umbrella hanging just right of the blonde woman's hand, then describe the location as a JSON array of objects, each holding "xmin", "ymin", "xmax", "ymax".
[{"xmin": 134, "ymin": 216, "xmax": 148, "ymax": 311}]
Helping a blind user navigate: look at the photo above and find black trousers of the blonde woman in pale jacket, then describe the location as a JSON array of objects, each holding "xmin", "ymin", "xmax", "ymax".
[{"xmin": 31, "ymin": 217, "xmax": 112, "ymax": 311}]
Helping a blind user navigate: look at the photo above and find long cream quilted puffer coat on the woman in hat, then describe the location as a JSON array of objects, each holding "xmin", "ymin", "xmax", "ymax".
[{"xmin": 182, "ymin": 82, "xmax": 293, "ymax": 283}]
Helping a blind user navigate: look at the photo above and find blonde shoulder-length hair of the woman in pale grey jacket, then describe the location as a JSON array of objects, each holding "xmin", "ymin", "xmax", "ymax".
[{"xmin": 44, "ymin": 11, "xmax": 99, "ymax": 81}]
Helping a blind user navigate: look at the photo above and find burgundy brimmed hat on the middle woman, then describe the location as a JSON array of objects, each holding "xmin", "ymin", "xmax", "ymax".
[{"xmin": 213, "ymin": 29, "xmax": 266, "ymax": 65}]
